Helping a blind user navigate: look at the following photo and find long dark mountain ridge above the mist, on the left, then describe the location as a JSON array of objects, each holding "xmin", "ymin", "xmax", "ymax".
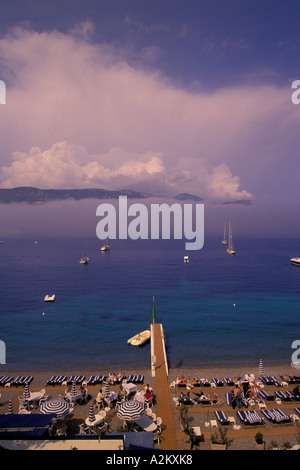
[{"xmin": 0, "ymin": 186, "xmax": 152, "ymax": 204}]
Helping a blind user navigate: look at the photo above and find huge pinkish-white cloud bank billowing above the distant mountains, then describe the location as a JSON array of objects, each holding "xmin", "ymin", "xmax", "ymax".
[{"xmin": 0, "ymin": 23, "xmax": 296, "ymax": 199}]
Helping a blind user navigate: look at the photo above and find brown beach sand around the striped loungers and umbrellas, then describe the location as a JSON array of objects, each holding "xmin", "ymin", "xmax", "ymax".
[{"xmin": 0, "ymin": 365, "xmax": 300, "ymax": 450}]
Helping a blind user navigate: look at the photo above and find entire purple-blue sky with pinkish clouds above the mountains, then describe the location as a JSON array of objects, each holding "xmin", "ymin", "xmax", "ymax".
[{"xmin": 0, "ymin": 0, "xmax": 300, "ymax": 209}]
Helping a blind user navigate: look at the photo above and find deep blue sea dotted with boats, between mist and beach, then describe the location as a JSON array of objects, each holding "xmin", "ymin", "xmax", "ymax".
[{"xmin": 0, "ymin": 238, "xmax": 300, "ymax": 372}]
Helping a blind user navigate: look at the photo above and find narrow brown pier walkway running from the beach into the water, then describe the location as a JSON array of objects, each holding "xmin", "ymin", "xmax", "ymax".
[{"xmin": 152, "ymin": 323, "xmax": 178, "ymax": 450}]
